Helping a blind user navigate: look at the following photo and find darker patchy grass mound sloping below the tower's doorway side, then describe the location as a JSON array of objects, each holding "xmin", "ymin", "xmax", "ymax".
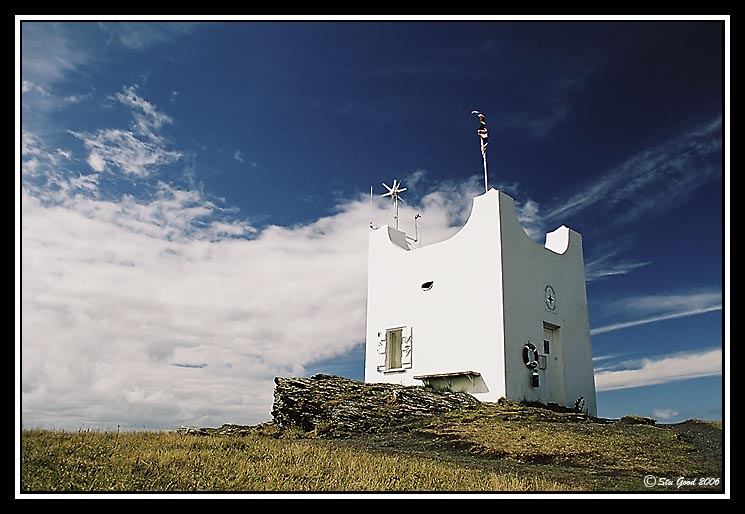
[{"xmin": 415, "ymin": 404, "xmax": 721, "ymax": 490}]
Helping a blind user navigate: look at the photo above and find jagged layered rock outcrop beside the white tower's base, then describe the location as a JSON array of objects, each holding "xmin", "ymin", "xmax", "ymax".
[{"xmin": 272, "ymin": 375, "xmax": 480, "ymax": 437}]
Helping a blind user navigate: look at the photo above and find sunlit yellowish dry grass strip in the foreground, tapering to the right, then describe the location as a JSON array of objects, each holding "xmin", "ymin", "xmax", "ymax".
[{"xmin": 21, "ymin": 430, "xmax": 565, "ymax": 492}]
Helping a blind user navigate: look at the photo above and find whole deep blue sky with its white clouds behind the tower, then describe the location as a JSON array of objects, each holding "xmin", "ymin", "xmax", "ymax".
[{"xmin": 17, "ymin": 21, "xmax": 725, "ymax": 428}]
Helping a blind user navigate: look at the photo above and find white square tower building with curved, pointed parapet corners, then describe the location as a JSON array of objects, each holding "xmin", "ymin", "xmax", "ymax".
[{"xmin": 365, "ymin": 189, "xmax": 597, "ymax": 415}]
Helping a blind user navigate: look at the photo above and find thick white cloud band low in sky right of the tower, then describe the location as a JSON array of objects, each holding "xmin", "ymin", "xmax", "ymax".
[{"xmin": 595, "ymin": 348, "xmax": 722, "ymax": 391}]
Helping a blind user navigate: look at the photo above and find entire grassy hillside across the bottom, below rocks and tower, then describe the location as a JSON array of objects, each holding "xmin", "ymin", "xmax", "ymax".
[{"xmin": 21, "ymin": 403, "xmax": 722, "ymax": 492}]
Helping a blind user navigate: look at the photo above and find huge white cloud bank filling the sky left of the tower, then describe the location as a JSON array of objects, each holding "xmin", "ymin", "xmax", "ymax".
[{"xmin": 21, "ymin": 169, "xmax": 478, "ymax": 428}]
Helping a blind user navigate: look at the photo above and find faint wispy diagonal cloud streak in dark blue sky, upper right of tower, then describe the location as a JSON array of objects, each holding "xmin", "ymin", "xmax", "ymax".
[{"xmin": 546, "ymin": 115, "xmax": 722, "ymax": 222}]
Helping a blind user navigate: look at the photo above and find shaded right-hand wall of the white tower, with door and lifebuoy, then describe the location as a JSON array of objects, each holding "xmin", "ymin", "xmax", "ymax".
[{"xmin": 499, "ymin": 193, "xmax": 597, "ymax": 415}]
